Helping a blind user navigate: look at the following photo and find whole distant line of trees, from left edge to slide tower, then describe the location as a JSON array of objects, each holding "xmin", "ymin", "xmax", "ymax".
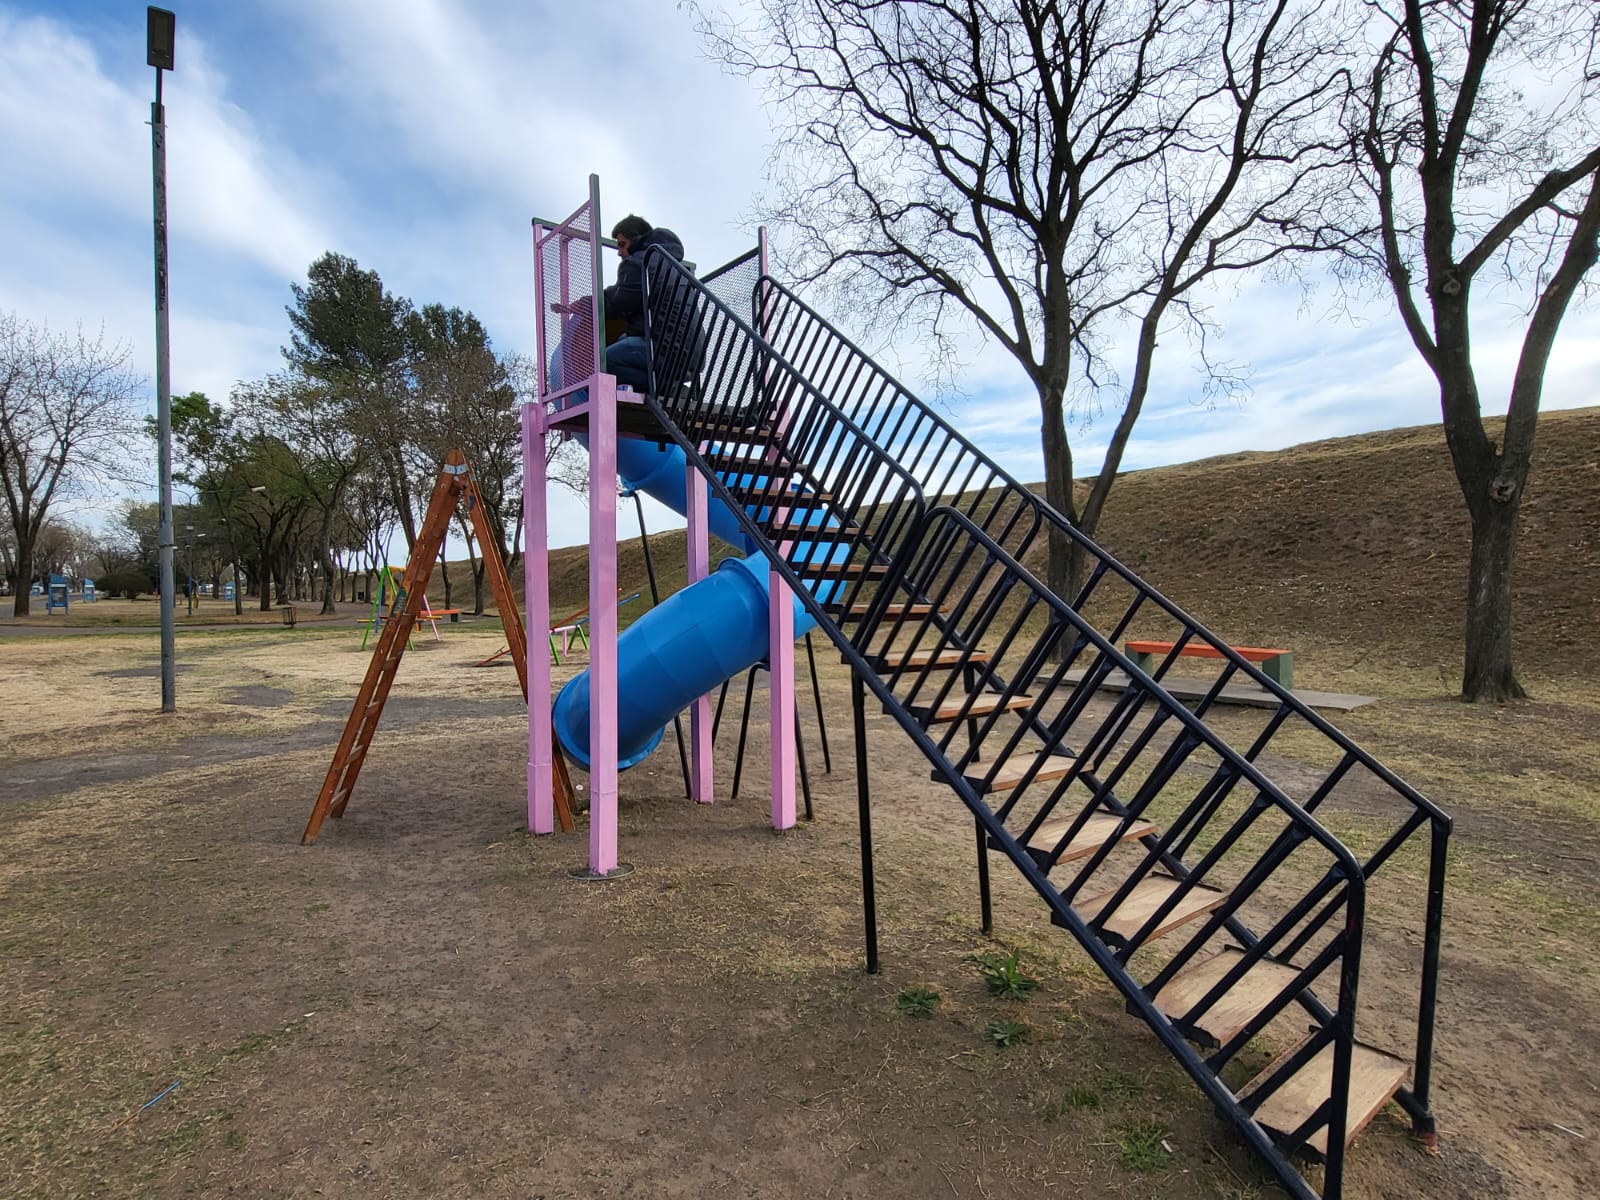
[{"xmin": 0, "ymin": 253, "xmax": 584, "ymax": 616}]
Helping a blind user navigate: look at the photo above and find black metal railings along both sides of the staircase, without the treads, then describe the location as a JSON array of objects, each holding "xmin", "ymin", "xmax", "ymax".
[{"xmin": 645, "ymin": 246, "xmax": 1450, "ymax": 1195}]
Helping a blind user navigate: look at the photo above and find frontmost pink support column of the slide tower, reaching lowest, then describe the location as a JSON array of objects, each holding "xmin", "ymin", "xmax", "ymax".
[{"xmin": 589, "ymin": 374, "xmax": 618, "ymax": 875}]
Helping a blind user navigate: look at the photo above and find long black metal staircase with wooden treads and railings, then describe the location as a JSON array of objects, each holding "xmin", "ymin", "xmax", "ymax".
[{"xmin": 624, "ymin": 246, "xmax": 1450, "ymax": 1197}]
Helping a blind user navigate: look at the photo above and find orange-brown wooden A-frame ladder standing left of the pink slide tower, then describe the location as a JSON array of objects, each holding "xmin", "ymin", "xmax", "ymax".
[{"xmin": 301, "ymin": 450, "xmax": 573, "ymax": 846}]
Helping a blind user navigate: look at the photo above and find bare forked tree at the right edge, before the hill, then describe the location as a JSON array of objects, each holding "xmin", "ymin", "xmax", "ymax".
[{"xmin": 1349, "ymin": 0, "xmax": 1600, "ymax": 701}]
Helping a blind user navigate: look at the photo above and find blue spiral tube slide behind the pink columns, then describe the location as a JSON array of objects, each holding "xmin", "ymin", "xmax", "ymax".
[{"xmin": 555, "ymin": 438, "xmax": 850, "ymax": 770}]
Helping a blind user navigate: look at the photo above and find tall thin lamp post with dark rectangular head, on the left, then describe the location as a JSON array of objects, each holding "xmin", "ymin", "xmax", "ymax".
[{"xmin": 144, "ymin": 6, "xmax": 178, "ymax": 712}]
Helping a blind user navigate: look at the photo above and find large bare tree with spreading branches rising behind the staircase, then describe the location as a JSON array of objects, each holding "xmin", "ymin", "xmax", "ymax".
[{"xmin": 706, "ymin": 0, "xmax": 1342, "ymax": 595}]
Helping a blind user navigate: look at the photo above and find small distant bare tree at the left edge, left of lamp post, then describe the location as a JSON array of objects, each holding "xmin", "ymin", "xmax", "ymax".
[{"xmin": 0, "ymin": 314, "xmax": 139, "ymax": 616}]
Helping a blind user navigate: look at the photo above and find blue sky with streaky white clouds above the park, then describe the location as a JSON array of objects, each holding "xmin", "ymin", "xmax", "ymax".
[{"xmin": 0, "ymin": 0, "xmax": 1600, "ymax": 542}]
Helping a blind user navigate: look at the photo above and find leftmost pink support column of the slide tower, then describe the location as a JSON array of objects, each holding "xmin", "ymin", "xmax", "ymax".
[{"xmin": 522, "ymin": 400, "xmax": 555, "ymax": 834}]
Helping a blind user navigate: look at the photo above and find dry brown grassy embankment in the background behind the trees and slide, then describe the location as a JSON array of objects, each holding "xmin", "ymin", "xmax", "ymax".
[{"xmin": 448, "ymin": 408, "xmax": 1600, "ymax": 688}]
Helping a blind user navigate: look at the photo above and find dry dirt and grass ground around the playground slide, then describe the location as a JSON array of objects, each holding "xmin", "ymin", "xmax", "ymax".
[{"xmin": 0, "ymin": 621, "xmax": 1600, "ymax": 1198}]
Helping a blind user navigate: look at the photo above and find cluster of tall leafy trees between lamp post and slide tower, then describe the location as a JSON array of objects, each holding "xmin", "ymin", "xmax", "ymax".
[{"xmin": 173, "ymin": 253, "xmax": 585, "ymax": 613}]
